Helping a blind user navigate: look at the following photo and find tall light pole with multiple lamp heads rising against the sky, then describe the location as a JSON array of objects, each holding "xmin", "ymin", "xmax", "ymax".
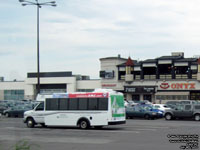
[{"xmin": 19, "ymin": 0, "xmax": 56, "ymax": 94}]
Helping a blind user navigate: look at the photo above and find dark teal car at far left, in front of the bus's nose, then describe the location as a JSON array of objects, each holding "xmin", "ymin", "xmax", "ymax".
[{"xmin": 3, "ymin": 106, "xmax": 32, "ymax": 118}]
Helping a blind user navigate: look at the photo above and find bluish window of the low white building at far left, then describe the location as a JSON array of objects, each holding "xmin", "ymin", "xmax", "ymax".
[{"xmin": 4, "ymin": 90, "xmax": 24, "ymax": 100}]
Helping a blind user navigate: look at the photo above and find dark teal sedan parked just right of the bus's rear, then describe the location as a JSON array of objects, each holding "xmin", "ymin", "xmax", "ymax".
[{"xmin": 126, "ymin": 105, "xmax": 159, "ymax": 119}]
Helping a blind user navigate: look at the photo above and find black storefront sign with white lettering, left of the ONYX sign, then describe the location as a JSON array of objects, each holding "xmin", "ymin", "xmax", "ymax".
[{"xmin": 124, "ymin": 87, "xmax": 155, "ymax": 93}]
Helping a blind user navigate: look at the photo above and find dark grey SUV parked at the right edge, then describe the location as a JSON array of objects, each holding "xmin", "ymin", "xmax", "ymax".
[{"xmin": 164, "ymin": 104, "xmax": 200, "ymax": 121}]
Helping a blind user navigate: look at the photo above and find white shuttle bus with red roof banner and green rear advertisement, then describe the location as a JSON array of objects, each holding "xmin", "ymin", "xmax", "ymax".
[{"xmin": 24, "ymin": 89, "xmax": 126, "ymax": 129}]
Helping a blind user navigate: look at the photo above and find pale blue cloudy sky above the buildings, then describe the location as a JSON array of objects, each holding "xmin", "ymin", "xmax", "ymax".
[{"xmin": 0, "ymin": 0, "xmax": 200, "ymax": 81}]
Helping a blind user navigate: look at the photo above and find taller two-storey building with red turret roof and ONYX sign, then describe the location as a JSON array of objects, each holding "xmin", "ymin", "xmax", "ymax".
[{"xmin": 100, "ymin": 53, "xmax": 200, "ymax": 103}]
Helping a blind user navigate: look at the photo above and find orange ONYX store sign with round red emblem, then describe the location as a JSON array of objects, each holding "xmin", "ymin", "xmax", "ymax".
[{"xmin": 160, "ymin": 83, "xmax": 196, "ymax": 90}]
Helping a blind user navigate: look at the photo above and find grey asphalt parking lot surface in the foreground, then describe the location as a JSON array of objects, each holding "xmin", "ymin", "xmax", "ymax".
[{"xmin": 0, "ymin": 118, "xmax": 200, "ymax": 150}]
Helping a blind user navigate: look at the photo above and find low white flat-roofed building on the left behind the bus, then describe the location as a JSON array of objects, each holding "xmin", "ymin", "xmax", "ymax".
[{"xmin": 0, "ymin": 72, "xmax": 101, "ymax": 100}]
